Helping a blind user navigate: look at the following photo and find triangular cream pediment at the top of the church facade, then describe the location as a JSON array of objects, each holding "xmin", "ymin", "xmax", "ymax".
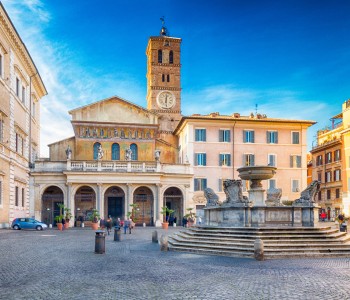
[{"xmin": 69, "ymin": 96, "xmax": 158, "ymax": 124}]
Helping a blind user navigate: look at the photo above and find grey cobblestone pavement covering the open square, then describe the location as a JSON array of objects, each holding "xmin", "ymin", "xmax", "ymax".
[{"xmin": 0, "ymin": 228, "xmax": 350, "ymax": 300}]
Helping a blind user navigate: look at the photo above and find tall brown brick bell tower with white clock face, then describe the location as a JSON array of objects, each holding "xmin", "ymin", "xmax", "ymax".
[{"xmin": 146, "ymin": 18, "xmax": 181, "ymax": 132}]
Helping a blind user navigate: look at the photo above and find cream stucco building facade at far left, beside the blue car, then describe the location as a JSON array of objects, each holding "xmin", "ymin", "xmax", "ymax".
[{"xmin": 0, "ymin": 2, "xmax": 47, "ymax": 228}]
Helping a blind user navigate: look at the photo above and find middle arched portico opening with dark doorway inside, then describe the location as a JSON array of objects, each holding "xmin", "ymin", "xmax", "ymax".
[{"xmin": 103, "ymin": 186, "xmax": 125, "ymax": 220}]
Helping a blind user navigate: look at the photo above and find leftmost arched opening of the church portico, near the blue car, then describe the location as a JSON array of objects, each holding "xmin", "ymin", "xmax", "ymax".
[{"xmin": 41, "ymin": 186, "xmax": 64, "ymax": 226}]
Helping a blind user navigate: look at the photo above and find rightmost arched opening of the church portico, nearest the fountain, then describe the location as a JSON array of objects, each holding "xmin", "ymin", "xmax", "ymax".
[{"xmin": 163, "ymin": 187, "xmax": 183, "ymax": 226}]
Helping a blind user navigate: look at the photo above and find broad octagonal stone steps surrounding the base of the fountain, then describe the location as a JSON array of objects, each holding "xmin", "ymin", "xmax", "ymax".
[{"xmin": 169, "ymin": 226, "xmax": 350, "ymax": 258}]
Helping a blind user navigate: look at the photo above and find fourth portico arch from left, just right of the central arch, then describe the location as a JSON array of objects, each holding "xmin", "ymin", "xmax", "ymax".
[{"xmin": 133, "ymin": 186, "xmax": 154, "ymax": 226}]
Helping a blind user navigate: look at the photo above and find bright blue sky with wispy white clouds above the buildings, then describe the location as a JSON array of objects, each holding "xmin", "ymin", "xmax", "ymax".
[{"xmin": 1, "ymin": 0, "xmax": 350, "ymax": 157}]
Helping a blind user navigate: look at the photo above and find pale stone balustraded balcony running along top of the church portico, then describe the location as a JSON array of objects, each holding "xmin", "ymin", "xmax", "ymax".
[{"xmin": 32, "ymin": 160, "xmax": 193, "ymax": 174}]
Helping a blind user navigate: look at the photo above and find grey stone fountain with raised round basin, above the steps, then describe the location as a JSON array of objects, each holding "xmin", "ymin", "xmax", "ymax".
[{"xmin": 204, "ymin": 166, "xmax": 320, "ymax": 227}]
